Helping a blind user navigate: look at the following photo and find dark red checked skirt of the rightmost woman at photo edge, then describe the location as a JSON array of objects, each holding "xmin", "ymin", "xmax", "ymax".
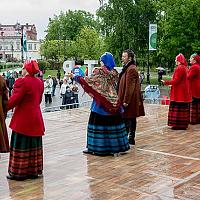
[{"xmin": 190, "ymin": 98, "xmax": 200, "ymax": 124}]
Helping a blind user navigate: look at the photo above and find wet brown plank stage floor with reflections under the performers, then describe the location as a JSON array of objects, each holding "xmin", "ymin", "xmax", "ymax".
[{"xmin": 0, "ymin": 104, "xmax": 200, "ymax": 200}]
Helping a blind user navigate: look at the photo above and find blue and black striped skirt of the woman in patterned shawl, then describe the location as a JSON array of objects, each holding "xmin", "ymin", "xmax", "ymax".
[{"xmin": 87, "ymin": 112, "xmax": 130, "ymax": 155}]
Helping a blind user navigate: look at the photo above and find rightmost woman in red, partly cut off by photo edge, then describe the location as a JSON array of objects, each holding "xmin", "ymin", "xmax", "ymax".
[{"xmin": 188, "ymin": 53, "xmax": 200, "ymax": 124}]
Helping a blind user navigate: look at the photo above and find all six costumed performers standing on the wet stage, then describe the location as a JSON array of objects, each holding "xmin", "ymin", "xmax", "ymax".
[{"xmin": 0, "ymin": 49, "xmax": 200, "ymax": 181}]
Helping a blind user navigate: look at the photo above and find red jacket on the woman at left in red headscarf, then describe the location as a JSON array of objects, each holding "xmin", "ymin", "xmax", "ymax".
[{"xmin": 8, "ymin": 75, "xmax": 45, "ymax": 136}]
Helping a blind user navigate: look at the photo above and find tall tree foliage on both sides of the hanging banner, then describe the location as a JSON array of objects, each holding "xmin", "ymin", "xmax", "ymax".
[{"xmin": 97, "ymin": 0, "xmax": 200, "ymax": 66}]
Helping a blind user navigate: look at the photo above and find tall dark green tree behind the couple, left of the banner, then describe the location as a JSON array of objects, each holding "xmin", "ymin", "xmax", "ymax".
[{"xmin": 97, "ymin": 0, "xmax": 156, "ymax": 64}]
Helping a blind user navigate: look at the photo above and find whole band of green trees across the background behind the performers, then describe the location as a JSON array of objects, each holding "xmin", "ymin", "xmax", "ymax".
[{"xmin": 41, "ymin": 0, "xmax": 200, "ymax": 70}]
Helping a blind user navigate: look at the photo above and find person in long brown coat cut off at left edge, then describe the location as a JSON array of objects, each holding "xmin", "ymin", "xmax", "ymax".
[{"xmin": 0, "ymin": 76, "xmax": 9, "ymax": 153}]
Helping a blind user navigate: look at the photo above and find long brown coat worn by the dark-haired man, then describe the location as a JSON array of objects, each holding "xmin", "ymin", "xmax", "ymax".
[{"xmin": 118, "ymin": 64, "xmax": 145, "ymax": 118}]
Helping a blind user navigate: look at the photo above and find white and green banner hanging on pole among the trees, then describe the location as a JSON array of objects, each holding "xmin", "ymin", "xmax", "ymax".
[{"xmin": 149, "ymin": 24, "xmax": 157, "ymax": 51}]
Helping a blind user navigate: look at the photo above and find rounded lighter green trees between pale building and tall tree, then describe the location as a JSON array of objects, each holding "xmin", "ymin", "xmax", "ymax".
[{"xmin": 41, "ymin": 10, "xmax": 103, "ymax": 62}]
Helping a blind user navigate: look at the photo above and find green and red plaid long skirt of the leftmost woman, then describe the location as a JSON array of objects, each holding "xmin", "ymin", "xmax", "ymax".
[{"xmin": 8, "ymin": 131, "xmax": 43, "ymax": 178}]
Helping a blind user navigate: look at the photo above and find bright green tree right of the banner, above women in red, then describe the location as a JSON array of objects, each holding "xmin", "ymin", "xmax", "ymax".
[{"xmin": 158, "ymin": 0, "xmax": 200, "ymax": 67}]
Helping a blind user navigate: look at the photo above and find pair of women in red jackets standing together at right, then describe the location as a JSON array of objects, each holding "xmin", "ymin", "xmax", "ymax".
[{"xmin": 162, "ymin": 53, "xmax": 200, "ymax": 130}]
